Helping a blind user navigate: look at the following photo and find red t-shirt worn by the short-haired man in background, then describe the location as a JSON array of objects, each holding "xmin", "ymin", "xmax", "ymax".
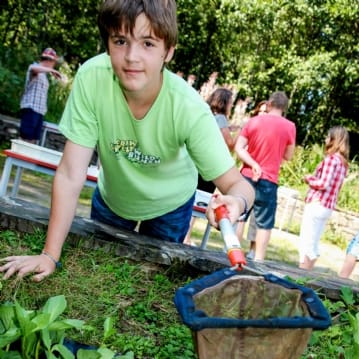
[{"xmin": 241, "ymin": 114, "xmax": 296, "ymax": 183}]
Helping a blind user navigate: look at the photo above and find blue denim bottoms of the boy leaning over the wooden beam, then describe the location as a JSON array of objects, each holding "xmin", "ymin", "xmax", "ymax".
[{"xmin": 91, "ymin": 187, "xmax": 195, "ymax": 243}]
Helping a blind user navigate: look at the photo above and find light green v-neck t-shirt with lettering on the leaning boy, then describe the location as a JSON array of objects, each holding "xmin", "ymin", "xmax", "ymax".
[{"xmin": 59, "ymin": 54, "xmax": 234, "ymax": 220}]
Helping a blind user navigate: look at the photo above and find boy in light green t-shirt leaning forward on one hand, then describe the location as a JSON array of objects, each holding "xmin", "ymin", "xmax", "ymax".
[{"xmin": 0, "ymin": 0, "xmax": 254, "ymax": 281}]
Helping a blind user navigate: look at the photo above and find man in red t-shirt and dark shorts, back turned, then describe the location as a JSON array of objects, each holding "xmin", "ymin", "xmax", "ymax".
[{"xmin": 235, "ymin": 91, "xmax": 296, "ymax": 261}]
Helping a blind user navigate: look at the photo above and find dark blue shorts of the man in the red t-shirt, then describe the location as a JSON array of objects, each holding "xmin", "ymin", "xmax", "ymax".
[{"xmin": 245, "ymin": 177, "xmax": 278, "ymax": 229}]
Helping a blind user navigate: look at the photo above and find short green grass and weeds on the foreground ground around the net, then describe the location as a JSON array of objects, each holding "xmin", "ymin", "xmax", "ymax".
[{"xmin": 0, "ymin": 230, "xmax": 359, "ymax": 359}]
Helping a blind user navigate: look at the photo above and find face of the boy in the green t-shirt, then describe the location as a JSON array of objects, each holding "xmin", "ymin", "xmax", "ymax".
[{"xmin": 108, "ymin": 14, "xmax": 174, "ymax": 97}]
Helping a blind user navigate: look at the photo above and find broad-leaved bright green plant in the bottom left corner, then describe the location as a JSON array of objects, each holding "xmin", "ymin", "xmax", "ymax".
[{"xmin": 0, "ymin": 295, "xmax": 133, "ymax": 359}]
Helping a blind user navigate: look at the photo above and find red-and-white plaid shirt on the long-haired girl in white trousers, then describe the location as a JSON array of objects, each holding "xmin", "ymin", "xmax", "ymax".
[{"xmin": 305, "ymin": 153, "xmax": 348, "ymax": 209}]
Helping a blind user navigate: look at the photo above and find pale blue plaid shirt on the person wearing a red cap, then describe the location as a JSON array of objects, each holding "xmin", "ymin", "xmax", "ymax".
[{"xmin": 20, "ymin": 62, "xmax": 49, "ymax": 115}]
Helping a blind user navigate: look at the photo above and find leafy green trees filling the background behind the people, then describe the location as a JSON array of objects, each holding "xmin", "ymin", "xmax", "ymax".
[{"xmin": 0, "ymin": 0, "xmax": 359, "ymax": 144}]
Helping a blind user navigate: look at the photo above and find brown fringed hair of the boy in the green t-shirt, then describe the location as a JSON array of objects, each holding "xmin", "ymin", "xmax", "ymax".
[{"xmin": 97, "ymin": 0, "xmax": 178, "ymax": 51}]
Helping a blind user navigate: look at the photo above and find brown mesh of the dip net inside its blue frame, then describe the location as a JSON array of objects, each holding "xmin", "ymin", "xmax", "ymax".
[{"xmin": 193, "ymin": 275, "xmax": 312, "ymax": 359}]
